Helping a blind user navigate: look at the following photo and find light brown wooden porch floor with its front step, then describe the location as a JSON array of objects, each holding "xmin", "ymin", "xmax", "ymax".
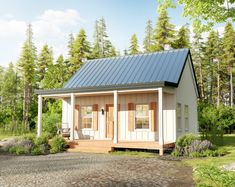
[{"xmin": 68, "ymin": 140, "xmax": 175, "ymax": 153}]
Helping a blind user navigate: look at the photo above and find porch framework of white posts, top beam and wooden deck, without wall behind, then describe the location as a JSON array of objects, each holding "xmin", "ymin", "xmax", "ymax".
[{"xmin": 37, "ymin": 87, "xmax": 175, "ymax": 155}]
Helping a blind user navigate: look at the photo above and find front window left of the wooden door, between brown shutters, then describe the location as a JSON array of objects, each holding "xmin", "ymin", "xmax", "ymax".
[{"xmin": 81, "ymin": 106, "xmax": 92, "ymax": 129}]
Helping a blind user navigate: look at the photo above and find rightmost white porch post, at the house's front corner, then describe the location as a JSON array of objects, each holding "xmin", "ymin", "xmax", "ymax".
[{"xmin": 158, "ymin": 88, "xmax": 164, "ymax": 155}]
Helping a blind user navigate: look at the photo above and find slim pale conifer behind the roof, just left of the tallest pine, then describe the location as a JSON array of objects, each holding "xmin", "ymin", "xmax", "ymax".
[{"xmin": 143, "ymin": 20, "xmax": 154, "ymax": 52}]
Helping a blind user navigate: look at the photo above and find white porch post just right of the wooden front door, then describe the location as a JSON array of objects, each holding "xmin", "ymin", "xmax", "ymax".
[{"xmin": 113, "ymin": 90, "xmax": 118, "ymax": 144}]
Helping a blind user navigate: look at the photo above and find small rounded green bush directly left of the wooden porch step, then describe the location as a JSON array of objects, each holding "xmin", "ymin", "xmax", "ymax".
[{"xmin": 50, "ymin": 135, "xmax": 66, "ymax": 153}]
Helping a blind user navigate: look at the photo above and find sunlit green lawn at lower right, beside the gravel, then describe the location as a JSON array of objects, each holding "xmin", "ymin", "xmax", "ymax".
[{"xmin": 184, "ymin": 134, "xmax": 235, "ymax": 186}]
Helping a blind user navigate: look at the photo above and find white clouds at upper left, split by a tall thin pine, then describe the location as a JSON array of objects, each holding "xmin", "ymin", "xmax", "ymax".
[{"xmin": 0, "ymin": 9, "xmax": 84, "ymax": 66}]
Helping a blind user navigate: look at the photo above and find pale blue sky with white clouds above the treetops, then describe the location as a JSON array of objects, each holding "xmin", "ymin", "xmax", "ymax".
[{"xmin": 0, "ymin": 0, "xmax": 204, "ymax": 67}]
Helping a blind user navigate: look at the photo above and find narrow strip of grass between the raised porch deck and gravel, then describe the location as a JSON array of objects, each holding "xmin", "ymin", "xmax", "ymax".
[{"xmin": 110, "ymin": 151, "xmax": 157, "ymax": 158}]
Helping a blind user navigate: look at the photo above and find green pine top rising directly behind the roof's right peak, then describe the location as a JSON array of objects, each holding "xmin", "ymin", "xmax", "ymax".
[{"xmin": 172, "ymin": 26, "xmax": 190, "ymax": 49}]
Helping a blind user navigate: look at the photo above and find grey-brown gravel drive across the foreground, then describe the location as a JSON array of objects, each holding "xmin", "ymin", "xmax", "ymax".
[{"xmin": 0, "ymin": 153, "xmax": 193, "ymax": 187}]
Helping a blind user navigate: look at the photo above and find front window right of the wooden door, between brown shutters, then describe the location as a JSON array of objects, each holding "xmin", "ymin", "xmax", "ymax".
[{"xmin": 135, "ymin": 104, "xmax": 149, "ymax": 129}]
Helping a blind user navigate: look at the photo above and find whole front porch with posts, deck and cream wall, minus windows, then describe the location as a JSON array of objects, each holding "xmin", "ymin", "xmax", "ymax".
[{"xmin": 38, "ymin": 88, "xmax": 175, "ymax": 154}]
